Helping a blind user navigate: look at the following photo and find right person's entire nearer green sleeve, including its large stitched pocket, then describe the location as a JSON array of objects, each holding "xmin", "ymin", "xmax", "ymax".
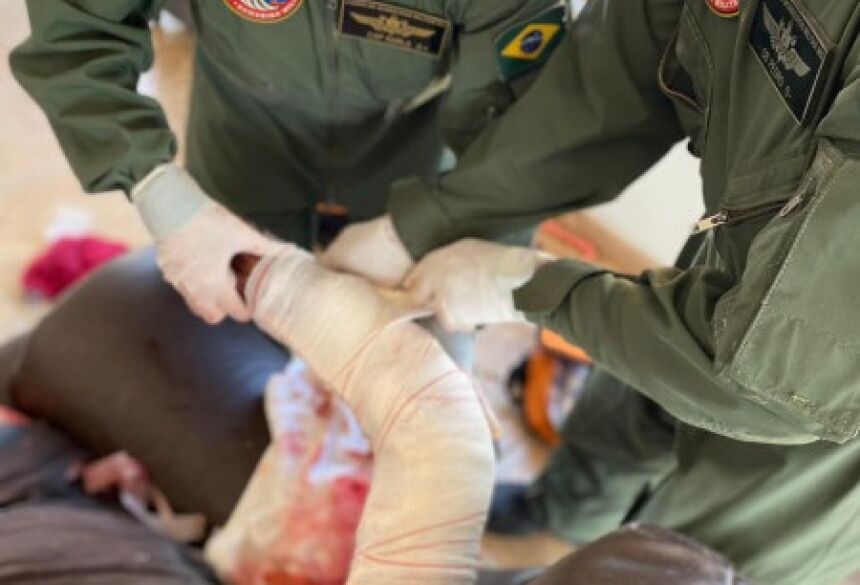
[{"xmin": 515, "ymin": 41, "xmax": 860, "ymax": 444}]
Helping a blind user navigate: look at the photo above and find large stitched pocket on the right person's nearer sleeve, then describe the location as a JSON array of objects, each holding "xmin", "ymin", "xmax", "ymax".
[{"xmin": 714, "ymin": 141, "xmax": 860, "ymax": 442}]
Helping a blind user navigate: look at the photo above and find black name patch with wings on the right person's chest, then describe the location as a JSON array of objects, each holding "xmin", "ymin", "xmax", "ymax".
[{"xmin": 749, "ymin": 0, "xmax": 832, "ymax": 124}]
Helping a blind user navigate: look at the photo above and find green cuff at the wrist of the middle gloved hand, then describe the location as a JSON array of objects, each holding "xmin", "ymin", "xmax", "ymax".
[{"xmin": 388, "ymin": 177, "xmax": 457, "ymax": 261}]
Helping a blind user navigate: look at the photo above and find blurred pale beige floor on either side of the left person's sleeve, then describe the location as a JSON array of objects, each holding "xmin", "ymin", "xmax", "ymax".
[{"xmin": 0, "ymin": 0, "xmax": 191, "ymax": 341}]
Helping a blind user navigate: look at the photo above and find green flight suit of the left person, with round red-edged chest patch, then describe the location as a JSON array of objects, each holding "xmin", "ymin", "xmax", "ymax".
[{"xmin": 11, "ymin": 0, "xmax": 565, "ymax": 246}]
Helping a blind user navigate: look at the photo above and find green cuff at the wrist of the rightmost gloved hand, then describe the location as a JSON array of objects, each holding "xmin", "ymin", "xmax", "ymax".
[{"xmin": 514, "ymin": 260, "xmax": 607, "ymax": 321}]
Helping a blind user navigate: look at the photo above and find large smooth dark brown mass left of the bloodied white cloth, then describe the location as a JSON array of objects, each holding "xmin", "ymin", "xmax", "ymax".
[{"xmin": 12, "ymin": 251, "xmax": 288, "ymax": 525}]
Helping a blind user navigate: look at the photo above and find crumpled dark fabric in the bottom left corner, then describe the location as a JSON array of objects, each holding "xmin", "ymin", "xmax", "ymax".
[{"xmin": 0, "ymin": 423, "xmax": 222, "ymax": 585}]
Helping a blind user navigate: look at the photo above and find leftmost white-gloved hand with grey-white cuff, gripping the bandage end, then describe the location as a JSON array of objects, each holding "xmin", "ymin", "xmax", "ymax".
[{"xmin": 131, "ymin": 164, "xmax": 271, "ymax": 324}]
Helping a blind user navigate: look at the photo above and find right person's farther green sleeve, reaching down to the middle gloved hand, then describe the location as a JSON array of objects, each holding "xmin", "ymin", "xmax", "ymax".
[{"xmin": 389, "ymin": 0, "xmax": 682, "ymax": 258}]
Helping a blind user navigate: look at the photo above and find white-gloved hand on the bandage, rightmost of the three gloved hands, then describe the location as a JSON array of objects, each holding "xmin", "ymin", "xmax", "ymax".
[{"xmin": 404, "ymin": 239, "xmax": 552, "ymax": 331}]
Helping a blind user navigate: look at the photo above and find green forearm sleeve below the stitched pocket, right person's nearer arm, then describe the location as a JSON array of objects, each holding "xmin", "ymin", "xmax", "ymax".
[{"xmin": 515, "ymin": 261, "xmax": 818, "ymax": 444}]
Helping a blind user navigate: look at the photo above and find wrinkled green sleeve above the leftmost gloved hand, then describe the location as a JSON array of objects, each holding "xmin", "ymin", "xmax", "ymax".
[{"xmin": 10, "ymin": 0, "xmax": 176, "ymax": 193}]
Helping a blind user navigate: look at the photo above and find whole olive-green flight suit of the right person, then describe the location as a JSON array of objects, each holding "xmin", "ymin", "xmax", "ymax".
[{"xmin": 391, "ymin": 0, "xmax": 860, "ymax": 585}]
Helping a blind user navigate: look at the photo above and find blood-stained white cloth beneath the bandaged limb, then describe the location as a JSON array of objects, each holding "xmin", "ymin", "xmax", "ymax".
[{"xmin": 205, "ymin": 359, "xmax": 373, "ymax": 585}]
